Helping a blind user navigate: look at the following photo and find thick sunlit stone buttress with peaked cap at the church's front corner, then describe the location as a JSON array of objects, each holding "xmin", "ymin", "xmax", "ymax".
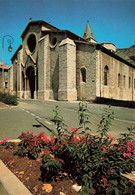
[{"xmin": 58, "ymin": 38, "xmax": 77, "ymax": 101}]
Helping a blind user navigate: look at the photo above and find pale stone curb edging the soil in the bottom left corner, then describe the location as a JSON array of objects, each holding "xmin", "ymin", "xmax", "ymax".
[{"xmin": 0, "ymin": 160, "xmax": 32, "ymax": 195}]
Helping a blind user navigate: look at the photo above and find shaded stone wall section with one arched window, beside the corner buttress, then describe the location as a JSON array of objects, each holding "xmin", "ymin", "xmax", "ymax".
[{"xmin": 76, "ymin": 43, "xmax": 96, "ymax": 100}]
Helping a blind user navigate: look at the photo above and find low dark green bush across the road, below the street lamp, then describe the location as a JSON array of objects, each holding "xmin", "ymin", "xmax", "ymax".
[{"xmin": 0, "ymin": 93, "xmax": 18, "ymax": 106}]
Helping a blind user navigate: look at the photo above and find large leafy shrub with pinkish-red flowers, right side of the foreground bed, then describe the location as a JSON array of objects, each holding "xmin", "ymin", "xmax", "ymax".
[{"xmin": 45, "ymin": 102, "xmax": 135, "ymax": 195}]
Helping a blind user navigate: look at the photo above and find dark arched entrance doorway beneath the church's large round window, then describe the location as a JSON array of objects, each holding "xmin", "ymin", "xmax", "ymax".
[{"xmin": 26, "ymin": 66, "xmax": 35, "ymax": 99}]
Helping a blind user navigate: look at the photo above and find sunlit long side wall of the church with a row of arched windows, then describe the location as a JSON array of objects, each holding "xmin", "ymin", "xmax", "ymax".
[{"xmin": 96, "ymin": 51, "xmax": 135, "ymax": 101}]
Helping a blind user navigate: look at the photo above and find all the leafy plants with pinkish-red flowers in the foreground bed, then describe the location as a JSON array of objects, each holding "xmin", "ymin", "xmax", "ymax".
[{"xmin": 1, "ymin": 103, "xmax": 135, "ymax": 195}]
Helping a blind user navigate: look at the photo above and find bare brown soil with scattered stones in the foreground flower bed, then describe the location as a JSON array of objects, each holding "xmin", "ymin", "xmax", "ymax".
[{"xmin": 0, "ymin": 147, "xmax": 77, "ymax": 195}]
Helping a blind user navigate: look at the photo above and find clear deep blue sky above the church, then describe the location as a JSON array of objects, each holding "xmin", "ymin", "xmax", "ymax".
[{"xmin": 0, "ymin": 0, "xmax": 135, "ymax": 66}]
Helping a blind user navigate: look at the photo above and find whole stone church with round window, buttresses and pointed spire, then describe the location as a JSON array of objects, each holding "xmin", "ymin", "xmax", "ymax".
[{"xmin": 9, "ymin": 20, "xmax": 135, "ymax": 101}]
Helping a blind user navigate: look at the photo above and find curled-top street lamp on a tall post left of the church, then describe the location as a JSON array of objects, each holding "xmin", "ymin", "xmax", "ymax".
[{"xmin": 2, "ymin": 35, "xmax": 14, "ymax": 93}]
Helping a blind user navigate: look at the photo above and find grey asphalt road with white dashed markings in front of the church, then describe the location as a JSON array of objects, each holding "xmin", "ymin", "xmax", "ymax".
[{"xmin": 0, "ymin": 100, "xmax": 135, "ymax": 139}]
